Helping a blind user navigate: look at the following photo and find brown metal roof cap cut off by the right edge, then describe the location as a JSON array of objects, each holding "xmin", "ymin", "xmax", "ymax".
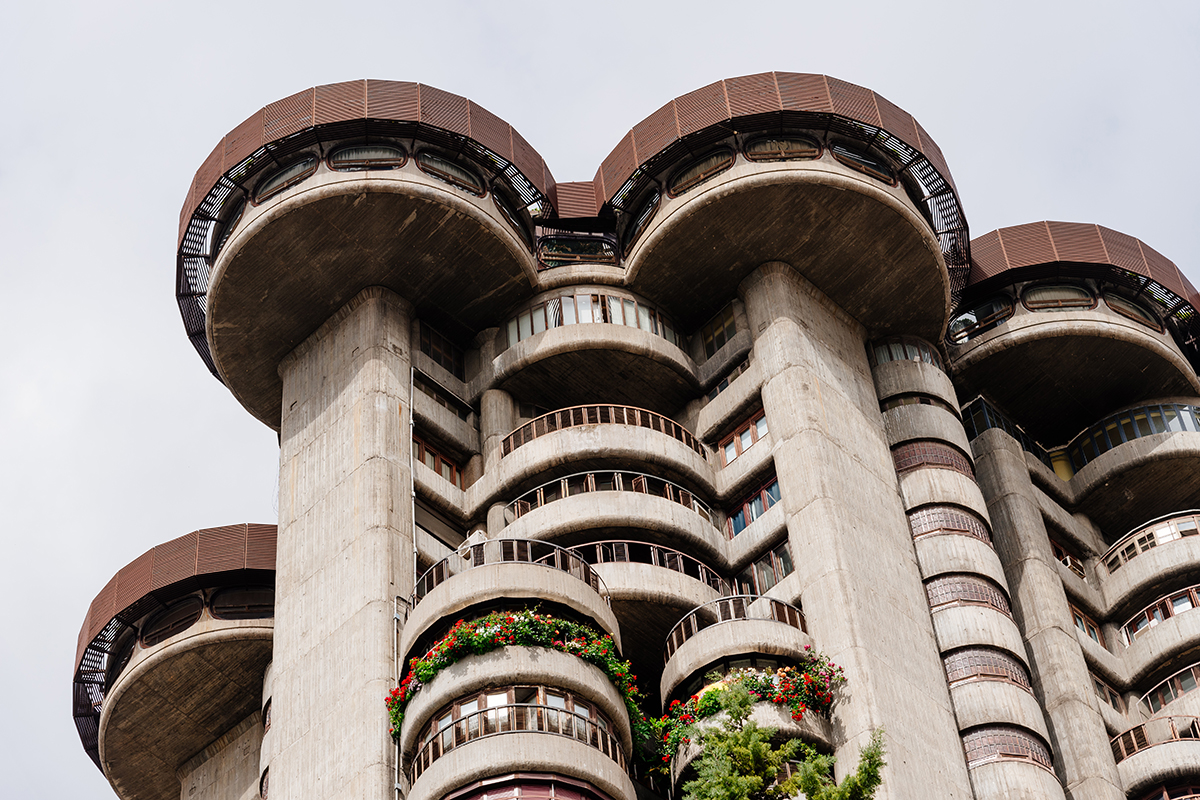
[{"xmin": 967, "ymin": 221, "xmax": 1200, "ymax": 308}]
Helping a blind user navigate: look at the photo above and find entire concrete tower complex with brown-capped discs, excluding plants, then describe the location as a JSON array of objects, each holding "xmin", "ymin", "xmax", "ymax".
[{"xmin": 74, "ymin": 73, "xmax": 1200, "ymax": 800}]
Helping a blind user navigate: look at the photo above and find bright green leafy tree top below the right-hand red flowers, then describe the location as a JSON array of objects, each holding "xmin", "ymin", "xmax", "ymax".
[{"xmin": 683, "ymin": 684, "xmax": 884, "ymax": 800}]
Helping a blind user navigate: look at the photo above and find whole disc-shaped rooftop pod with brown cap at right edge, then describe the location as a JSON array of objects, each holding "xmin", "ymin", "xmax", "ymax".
[{"xmin": 949, "ymin": 222, "xmax": 1200, "ymax": 444}]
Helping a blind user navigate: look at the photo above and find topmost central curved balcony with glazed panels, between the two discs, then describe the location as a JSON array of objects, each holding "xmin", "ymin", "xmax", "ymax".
[{"xmin": 494, "ymin": 287, "xmax": 700, "ymax": 410}]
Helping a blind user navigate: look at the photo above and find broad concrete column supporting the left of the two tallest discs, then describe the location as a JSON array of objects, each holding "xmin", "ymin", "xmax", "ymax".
[{"xmin": 270, "ymin": 288, "xmax": 413, "ymax": 800}]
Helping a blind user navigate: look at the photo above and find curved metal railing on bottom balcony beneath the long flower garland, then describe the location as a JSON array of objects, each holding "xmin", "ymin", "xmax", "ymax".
[{"xmin": 412, "ymin": 703, "xmax": 625, "ymax": 781}]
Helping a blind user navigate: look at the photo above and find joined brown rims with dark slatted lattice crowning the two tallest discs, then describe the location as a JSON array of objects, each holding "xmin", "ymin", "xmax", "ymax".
[{"xmin": 176, "ymin": 72, "xmax": 970, "ymax": 400}]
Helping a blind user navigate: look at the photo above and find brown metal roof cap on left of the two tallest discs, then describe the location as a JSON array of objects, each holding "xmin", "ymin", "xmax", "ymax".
[{"xmin": 179, "ymin": 80, "xmax": 554, "ymax": 243}]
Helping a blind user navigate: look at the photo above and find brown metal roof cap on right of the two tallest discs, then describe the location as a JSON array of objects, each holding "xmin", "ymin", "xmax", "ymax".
[{"xmin": 594, "ymin": 72, "xmax": 958, "ymax": 201}]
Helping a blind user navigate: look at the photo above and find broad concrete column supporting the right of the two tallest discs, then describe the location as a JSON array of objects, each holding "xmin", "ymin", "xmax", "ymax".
[{"xmin": 739, "ymin": 263, "xmax": 971, "ymax": 800}]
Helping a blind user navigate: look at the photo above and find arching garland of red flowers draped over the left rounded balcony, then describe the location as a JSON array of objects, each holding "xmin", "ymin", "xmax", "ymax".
[{"xmin": 386, "ymin": 608, "xmax": 652, "ymax": 740}]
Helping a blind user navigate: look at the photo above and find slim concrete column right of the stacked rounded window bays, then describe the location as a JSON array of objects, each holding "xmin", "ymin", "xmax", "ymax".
[{"xmin": 971, "ymin": 429, "xmax": 1124, "ymax": 800}]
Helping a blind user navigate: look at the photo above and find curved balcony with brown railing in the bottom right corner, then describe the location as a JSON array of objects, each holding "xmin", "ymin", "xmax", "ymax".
[{"xmin": 1111, "ymin": 716, "xmax": 1200, "ymax": 793}]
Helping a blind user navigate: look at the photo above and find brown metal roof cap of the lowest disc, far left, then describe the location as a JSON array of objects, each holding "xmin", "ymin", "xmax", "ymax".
[{"xmin": 76, "ymin": 523, "xmax": 276, "ymax": 668}]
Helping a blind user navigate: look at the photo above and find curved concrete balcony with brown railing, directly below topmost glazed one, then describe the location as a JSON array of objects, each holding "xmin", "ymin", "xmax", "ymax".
[{"xmin": 498, "ymin": 404, "xmax": 713, "ymax": 495}]
